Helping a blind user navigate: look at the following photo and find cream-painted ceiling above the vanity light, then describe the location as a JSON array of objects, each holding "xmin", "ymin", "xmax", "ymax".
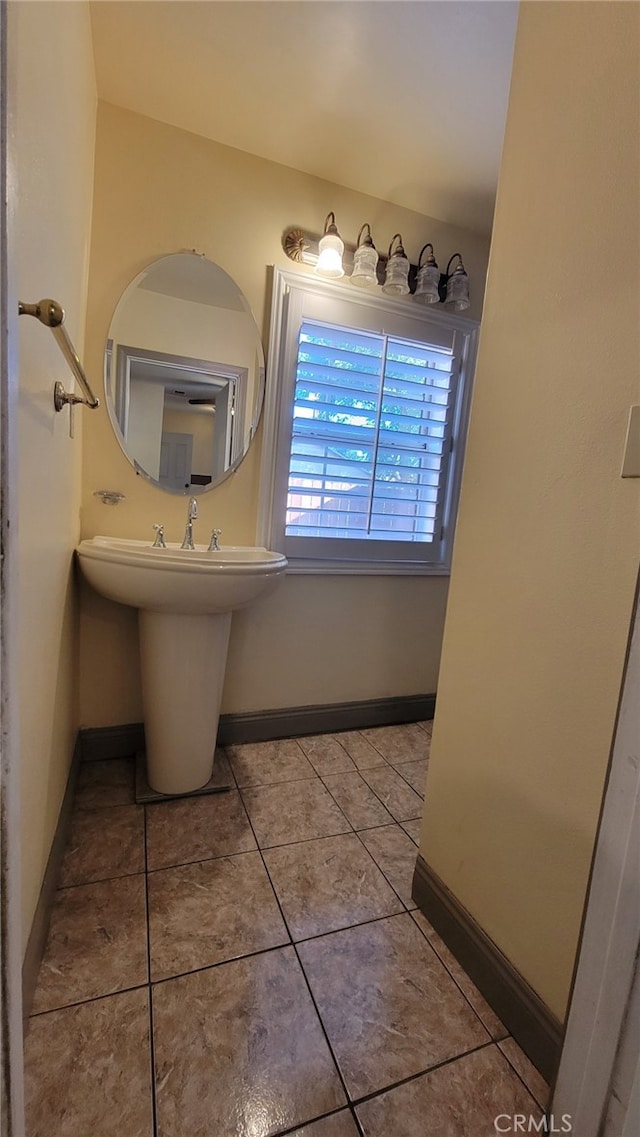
[{"xmin": 91, "ymin": 0, "xmax": 518, "ymax": 233}]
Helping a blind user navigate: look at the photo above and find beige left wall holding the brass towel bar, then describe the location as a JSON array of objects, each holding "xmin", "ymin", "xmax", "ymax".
[{"xmin": 9, "ymin": 3, "xmax": 95, "ymax": 943}]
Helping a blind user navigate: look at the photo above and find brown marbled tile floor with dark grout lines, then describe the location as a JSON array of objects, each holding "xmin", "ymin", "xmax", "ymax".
[{"xmin": 25, "ymin": 723, "xmax": 548, "ymax": 1137}]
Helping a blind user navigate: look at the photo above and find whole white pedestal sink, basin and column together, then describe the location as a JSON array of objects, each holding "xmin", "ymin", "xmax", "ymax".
[{"xmin": 76, "ymin": 537, "xmax": 286, "ymax": 794}]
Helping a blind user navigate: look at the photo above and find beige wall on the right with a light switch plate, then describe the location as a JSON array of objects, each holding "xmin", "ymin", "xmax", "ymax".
[{"xmin": 421, "ymin": 3, "xmax": 640, "ymax": 1016}]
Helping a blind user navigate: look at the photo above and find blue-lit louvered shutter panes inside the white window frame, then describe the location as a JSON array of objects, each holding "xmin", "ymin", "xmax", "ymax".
[{"xmin": 284, "ymin": 319, "xmax": 454, "ymax": 542}]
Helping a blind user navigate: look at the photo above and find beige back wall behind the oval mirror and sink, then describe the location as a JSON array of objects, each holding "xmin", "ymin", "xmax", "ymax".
[{"xmin": 81, "ymin": 103, "xmax": 488, "ymax": 727}]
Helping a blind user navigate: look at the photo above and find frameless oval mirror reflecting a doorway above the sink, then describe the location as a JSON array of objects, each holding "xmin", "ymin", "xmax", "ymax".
[{"xmin": 105, "ymin": 252, "xmax": 265, "ymax": 495}]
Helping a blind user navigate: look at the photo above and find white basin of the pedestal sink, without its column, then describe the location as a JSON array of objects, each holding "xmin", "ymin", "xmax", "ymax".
[{"xmin": 77, "ymin": 537, "xmax": 286, "ymax": 615}]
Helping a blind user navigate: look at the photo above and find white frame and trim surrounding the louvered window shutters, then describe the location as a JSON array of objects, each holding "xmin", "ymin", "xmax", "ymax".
[{"xmin": 257, "ymin": 267, "xmax": 479, "ymax": 576}]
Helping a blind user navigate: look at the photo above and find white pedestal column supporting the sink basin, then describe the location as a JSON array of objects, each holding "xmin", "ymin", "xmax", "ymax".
[{"xmin": 139, "ymin": 609, "xmax": 231, "ymax": 794}]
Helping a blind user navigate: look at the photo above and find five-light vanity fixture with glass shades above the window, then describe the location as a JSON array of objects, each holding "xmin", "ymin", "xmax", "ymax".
[{"xmin": 282, "ymin": 211, "xmax": 471, "ymax": 312}]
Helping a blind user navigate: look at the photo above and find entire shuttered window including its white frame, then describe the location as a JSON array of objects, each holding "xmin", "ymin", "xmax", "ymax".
[{"xmin": 260, "ymin": 269, "xmax": 476, "ymax": 573}]
